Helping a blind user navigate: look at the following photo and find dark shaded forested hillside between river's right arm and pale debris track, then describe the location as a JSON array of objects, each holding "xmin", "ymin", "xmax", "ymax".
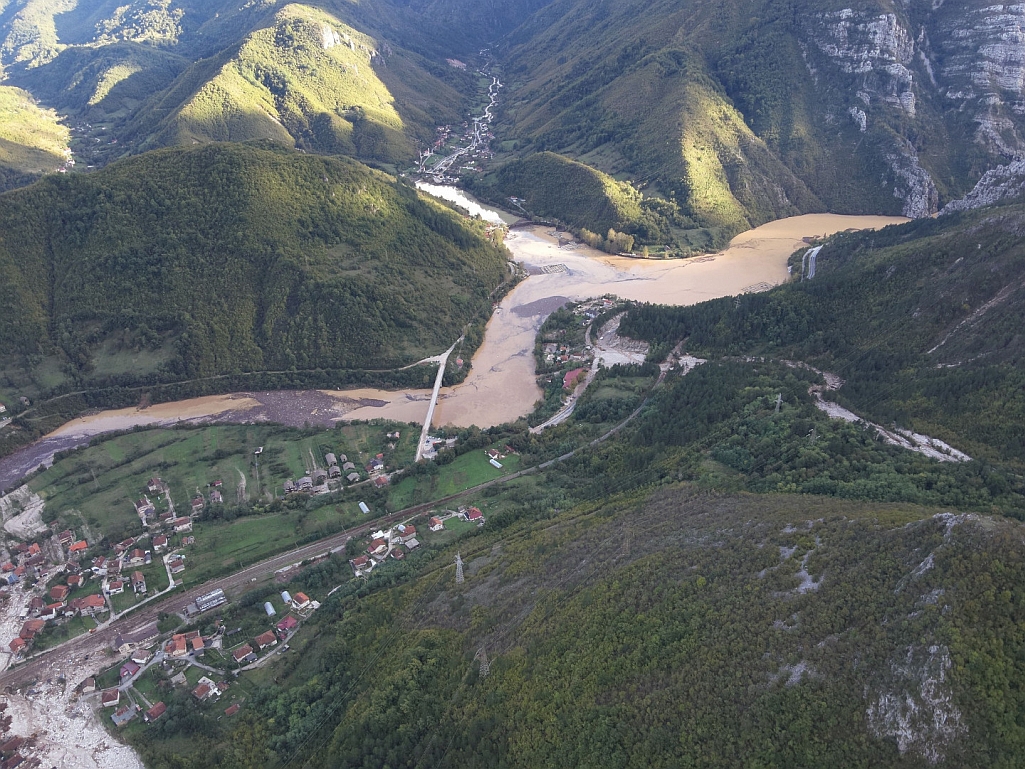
[{"xmin": 621, "ymin": 204, "xmax": 1025, "ymax": 464}]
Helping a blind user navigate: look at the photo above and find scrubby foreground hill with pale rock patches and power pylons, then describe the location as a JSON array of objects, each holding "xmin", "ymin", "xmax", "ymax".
[{"xmin": 128, "ymin": 479, "xmax": 1025, "ymax": 769}]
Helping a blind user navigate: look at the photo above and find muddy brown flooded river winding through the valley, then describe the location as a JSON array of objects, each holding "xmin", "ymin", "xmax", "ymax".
[{"xmin": 0, "ymin": 185, "xmax": 906, "ymax": 488}]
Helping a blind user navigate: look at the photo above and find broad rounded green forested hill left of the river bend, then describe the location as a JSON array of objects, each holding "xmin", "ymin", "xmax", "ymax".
[{"xmin": 0, "ymin": 145, "xmax": 505, "ymax": 385}]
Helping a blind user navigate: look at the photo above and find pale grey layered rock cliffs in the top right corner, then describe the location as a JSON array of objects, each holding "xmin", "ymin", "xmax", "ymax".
[{"xmin": 801, "ymin": 0, "xmax": 1025, "ymax": 216}]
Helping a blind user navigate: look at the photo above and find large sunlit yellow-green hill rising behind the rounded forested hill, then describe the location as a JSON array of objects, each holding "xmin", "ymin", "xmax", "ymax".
[{"xmin": 149, "ymin": 5, "xmax": 459, "ymax": 161}]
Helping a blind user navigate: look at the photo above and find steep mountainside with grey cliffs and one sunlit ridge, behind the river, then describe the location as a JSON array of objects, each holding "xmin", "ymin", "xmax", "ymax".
[{"xmin": 494, "ymin": 0, "xmax": 1025, "ymax": 237}]
